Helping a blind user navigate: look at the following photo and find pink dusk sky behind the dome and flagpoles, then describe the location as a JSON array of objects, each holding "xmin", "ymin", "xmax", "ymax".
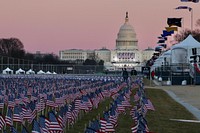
[{"xmin": 0, "ymin": 0, "xmax": 200, "ymax": 54}]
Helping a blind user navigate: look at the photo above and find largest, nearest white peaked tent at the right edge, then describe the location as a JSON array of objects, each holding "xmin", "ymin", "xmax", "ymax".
[{"xmin": 171, "ymin": 35, "xmax": 200, "ymax": 63}]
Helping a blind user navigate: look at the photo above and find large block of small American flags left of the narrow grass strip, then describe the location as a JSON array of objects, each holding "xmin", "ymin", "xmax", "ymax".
[{"xmin": 0, "ymin": 75, "xmax": 141, "ymax": 133}]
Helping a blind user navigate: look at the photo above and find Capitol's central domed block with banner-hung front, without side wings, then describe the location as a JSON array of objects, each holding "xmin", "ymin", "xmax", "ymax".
[{"xmin": 110, "ymin": 12, "xmax": 142, "ymax": 69}]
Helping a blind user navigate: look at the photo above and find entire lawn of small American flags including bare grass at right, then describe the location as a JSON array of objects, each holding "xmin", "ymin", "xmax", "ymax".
[{"xmin": 0, "ymin": 75, "xmax": 199, "ymax": 133}]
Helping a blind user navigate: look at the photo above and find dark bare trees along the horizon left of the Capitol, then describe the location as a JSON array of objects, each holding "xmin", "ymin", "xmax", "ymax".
[{"xmin": 0, "ymin": 38, "xmax": 104, "ymax": 65}]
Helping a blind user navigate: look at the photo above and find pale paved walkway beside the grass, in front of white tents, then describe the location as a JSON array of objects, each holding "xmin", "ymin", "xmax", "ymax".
[{"xmin": 145, "ymin": 83, "xmax": 200, "ymax": 120}]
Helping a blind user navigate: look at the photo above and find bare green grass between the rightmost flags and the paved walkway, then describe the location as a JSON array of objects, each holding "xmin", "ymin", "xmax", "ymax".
[{"xmin": 146, "ymin": 88, "xmax": 200, "ymax": 133}]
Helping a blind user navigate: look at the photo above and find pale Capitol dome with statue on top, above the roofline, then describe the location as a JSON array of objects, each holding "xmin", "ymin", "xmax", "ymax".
[{"xmin": 116, "ymin": 12, "xmax": 138, "ymax": 50}]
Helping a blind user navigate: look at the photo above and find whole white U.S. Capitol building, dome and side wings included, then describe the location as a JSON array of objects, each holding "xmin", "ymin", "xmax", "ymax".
[{"xmin": 59, "ymin": 12, "xmax": 154, "ymax": 70}]
